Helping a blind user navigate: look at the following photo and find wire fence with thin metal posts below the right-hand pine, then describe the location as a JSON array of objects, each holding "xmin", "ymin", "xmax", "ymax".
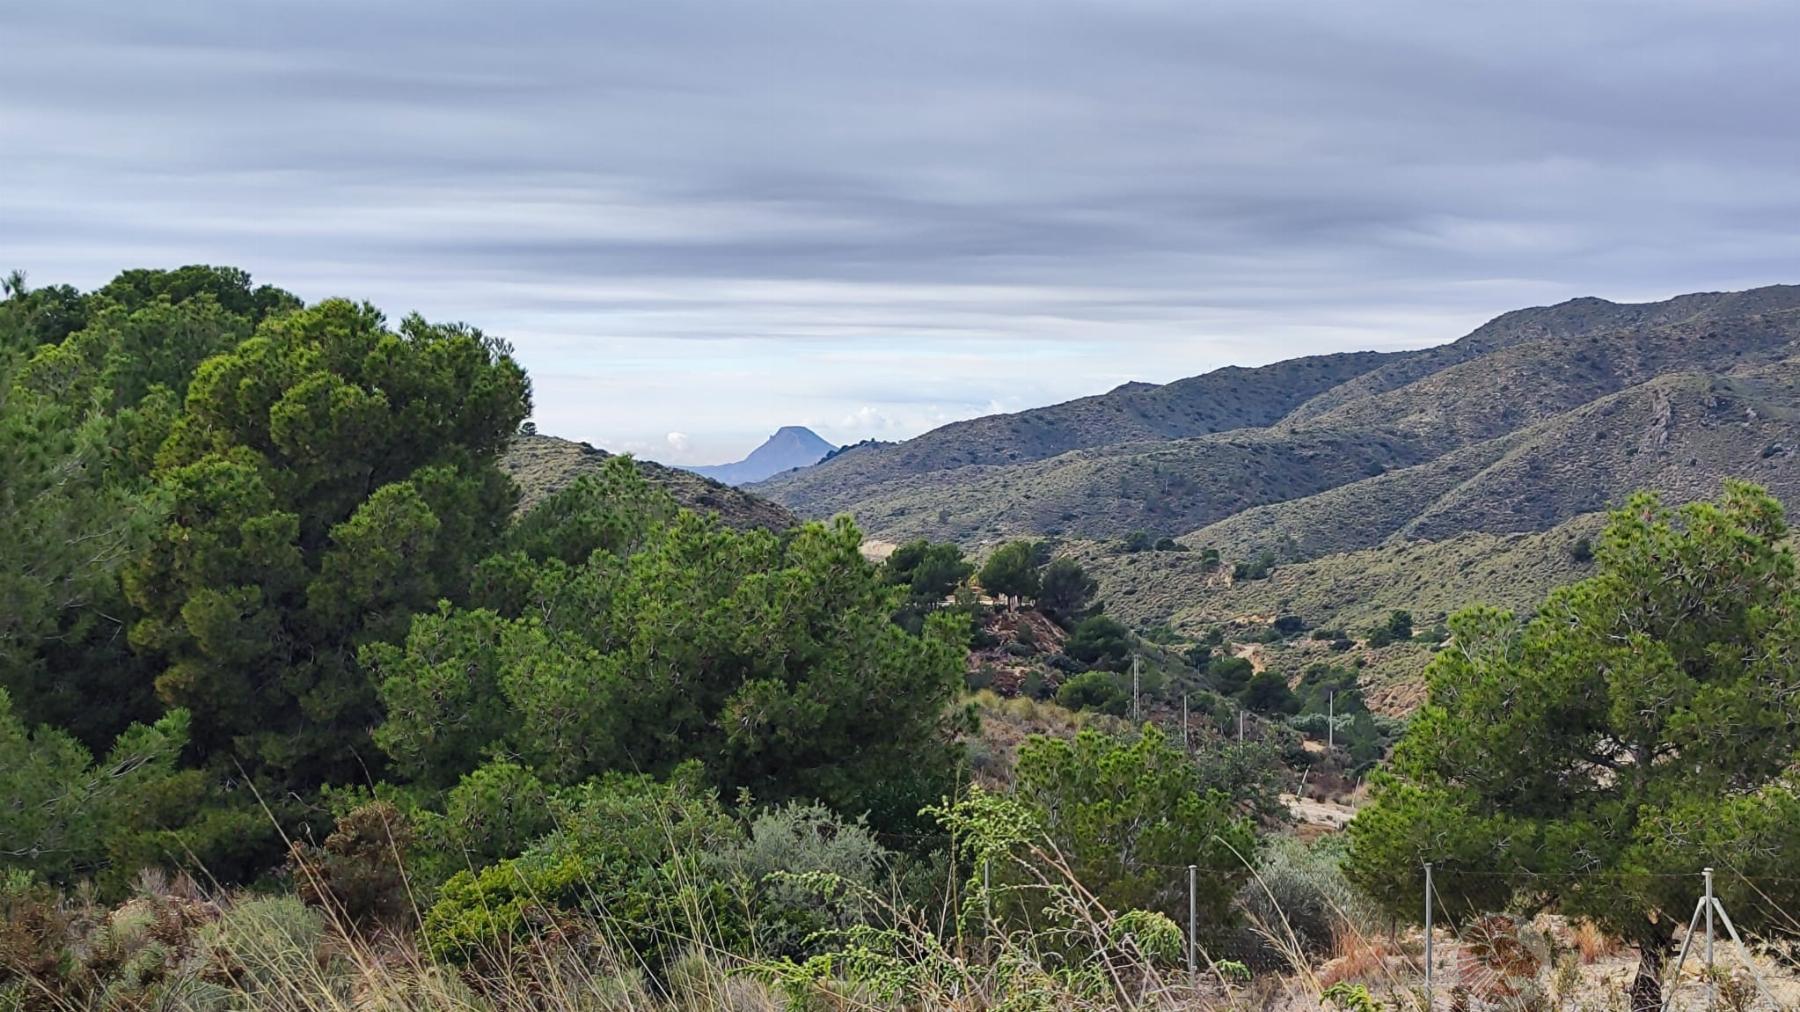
[{"xmin": 1094, "ymin": 864, "xmax": 1800, "ymax": 1012}]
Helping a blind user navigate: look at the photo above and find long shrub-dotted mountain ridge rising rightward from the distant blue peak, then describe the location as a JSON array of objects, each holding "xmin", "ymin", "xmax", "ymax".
[{"xmin": 756, "ymin": 285, "xmax": 1800, "ymax": 546}]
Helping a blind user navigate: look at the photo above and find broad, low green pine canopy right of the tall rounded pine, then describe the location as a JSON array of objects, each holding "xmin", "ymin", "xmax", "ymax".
[{"xmin": 364, "ymin": 459, "xmax": 967, "ymax": 827}]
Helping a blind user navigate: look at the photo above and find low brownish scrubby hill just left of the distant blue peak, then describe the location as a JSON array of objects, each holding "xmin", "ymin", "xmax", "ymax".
[{"xmin": 500, "ymin": 436, "xmax": 799, "ymax": 531}]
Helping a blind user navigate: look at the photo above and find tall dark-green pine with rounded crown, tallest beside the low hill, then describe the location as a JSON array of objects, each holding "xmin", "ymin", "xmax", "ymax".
[{"xmin": 124, "ymin": 301, "xmax": 529, "ymax": 783}]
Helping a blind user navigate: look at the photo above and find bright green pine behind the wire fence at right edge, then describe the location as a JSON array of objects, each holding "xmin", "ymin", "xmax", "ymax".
[{"xmin": 1350, "ymin": 483, "xmax": 1800, "ymax": 1008}]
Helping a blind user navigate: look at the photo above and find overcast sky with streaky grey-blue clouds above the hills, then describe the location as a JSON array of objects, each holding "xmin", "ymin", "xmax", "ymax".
[{"xmin": 0, "ymin": 0, "xmax": 1800, "ymax": 463}]
